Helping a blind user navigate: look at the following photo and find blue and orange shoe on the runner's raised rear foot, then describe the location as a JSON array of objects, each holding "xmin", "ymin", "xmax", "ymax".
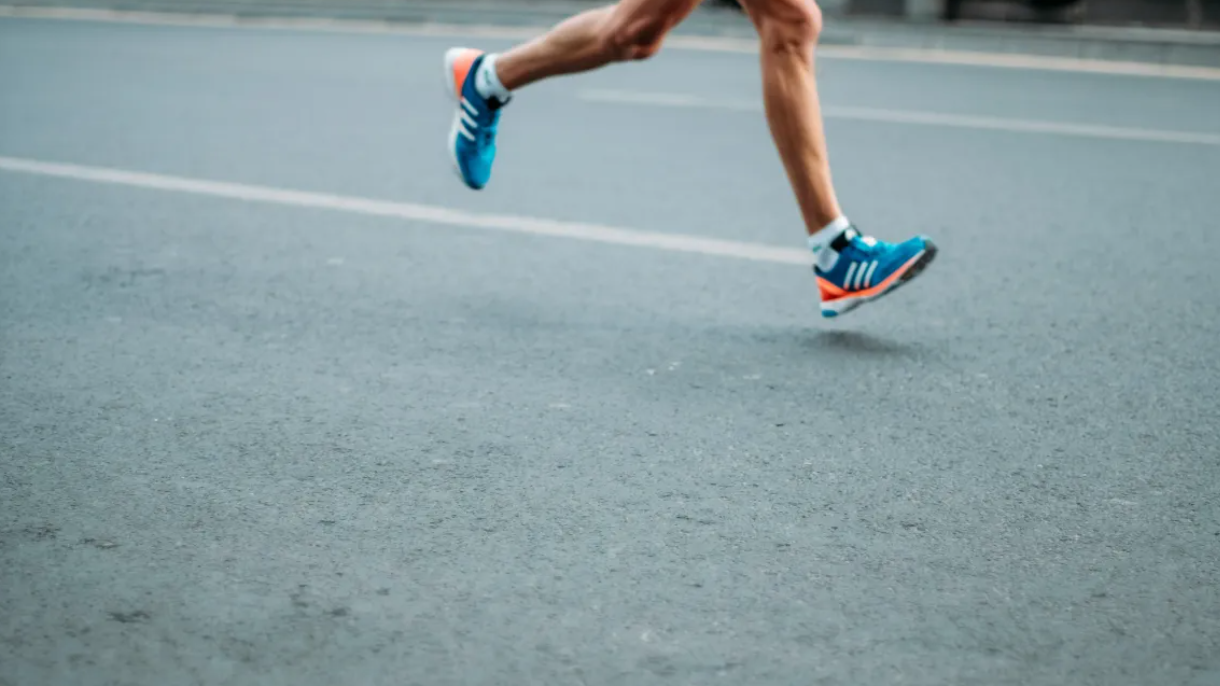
[{"xmin": 445, "ymin": 48, "xmax": 509, "ymax": 190}]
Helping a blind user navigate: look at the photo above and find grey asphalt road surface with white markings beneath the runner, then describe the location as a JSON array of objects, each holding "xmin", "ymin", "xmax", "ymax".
[{"xmin": 0, "ymin": 14, "xmax": 1220, "ymax": 686}]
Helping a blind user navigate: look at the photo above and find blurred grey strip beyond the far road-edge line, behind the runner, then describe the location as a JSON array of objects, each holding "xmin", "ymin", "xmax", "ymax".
[{"xmin": 4, "ymin": 0, "xmax": 1220, "ymax": 67}]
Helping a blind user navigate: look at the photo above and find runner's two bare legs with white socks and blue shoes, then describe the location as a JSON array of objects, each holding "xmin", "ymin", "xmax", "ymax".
[{"xmin": 445, "ymin": 0, "xmax": 937, "ymax": 317}]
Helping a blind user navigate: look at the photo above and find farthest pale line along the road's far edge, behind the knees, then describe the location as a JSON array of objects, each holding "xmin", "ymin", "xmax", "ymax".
[{"xmin": 0, "ymin": 5, "xmax": 1220, "ymax": 81}]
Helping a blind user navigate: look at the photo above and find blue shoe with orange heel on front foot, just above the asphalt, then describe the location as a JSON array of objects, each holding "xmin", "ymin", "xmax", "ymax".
[{"xmin": 814, "ymin": 226, "xmax": 936, "ymax": 317}]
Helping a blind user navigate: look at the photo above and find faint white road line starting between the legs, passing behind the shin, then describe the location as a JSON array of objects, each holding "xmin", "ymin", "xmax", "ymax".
[{"xmin": 577, "ymin": 90, "xmax": 1220, "ymax": 146}]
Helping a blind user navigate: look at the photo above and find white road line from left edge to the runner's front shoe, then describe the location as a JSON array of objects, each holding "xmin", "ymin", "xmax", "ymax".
[{"xmin": 0, "ymin": 156, "xmax": 813, "ymax": 266}]
